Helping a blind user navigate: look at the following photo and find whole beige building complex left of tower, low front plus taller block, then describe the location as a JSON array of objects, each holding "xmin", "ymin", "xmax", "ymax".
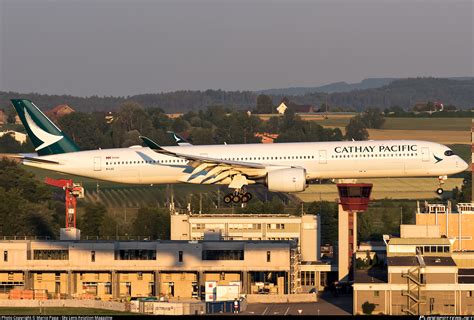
[{"xmin": 0, "ymin": 214, "xmax": 334, "ymax": 300}]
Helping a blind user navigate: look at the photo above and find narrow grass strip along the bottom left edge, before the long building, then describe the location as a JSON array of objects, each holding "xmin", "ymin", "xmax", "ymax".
[{"xmin": 0, "ymin": 307, "xmax": 133, "ymax": 316}]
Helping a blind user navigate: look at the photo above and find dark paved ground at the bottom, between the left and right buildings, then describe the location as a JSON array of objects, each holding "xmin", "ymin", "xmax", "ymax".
[{"xmin": 242, "ymin": 295, "xmax": 352, "ymax": 316}]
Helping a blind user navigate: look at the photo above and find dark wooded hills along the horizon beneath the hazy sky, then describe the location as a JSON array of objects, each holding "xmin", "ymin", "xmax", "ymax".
[{"xmin": 0, "ymin": 78, "xmax": 474, "ymax": 113}]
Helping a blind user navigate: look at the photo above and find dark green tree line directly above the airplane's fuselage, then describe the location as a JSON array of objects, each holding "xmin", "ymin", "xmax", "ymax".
[{"xmin": 0, "ymin": 101, "xmax": 384, "ymax": 153}]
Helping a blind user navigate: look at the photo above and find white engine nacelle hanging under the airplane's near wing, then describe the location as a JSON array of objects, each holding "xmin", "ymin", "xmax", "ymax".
[{"xmin": 266, "ymin": 168, "xmax": 306, "ymax": 192}]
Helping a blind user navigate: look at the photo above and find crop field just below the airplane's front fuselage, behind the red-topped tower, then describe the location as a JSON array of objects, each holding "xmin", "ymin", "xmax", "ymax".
[{"xmin": 295, "ymin": 178, "xmax": 463, "ymax": 202}]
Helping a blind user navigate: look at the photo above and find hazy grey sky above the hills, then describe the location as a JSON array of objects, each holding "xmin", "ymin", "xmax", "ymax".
[{"xmin": 0, "ymin": 0, "xmax": 474, "ymax": 96}]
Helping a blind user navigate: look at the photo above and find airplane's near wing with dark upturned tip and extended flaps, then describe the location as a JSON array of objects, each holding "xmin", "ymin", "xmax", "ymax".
[{"xmin": 140, "ymin": 136, "xmax": 271, "ymax": 188}]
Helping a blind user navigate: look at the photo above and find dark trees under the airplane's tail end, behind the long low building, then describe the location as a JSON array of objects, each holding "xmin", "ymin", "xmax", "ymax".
[{"xmin": 0, "ymin": 159, "xmax": 170, "ymax": 239}]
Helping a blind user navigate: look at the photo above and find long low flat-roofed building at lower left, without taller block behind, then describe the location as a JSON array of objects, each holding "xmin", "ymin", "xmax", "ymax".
[{"xmin": 0, "ymin": 240, "xmax": 295, "ymax": 300}]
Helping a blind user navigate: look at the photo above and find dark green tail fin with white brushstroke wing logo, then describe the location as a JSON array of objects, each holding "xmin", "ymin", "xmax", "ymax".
[{"xmin": 11, "ymin": 99, "xmax": 80, "ymax": 156}]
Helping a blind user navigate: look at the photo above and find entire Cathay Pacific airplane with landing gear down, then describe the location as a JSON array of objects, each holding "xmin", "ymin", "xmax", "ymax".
[{"xmin": 4, "ymin": 99, "xmax": 468, "ymax": 203}]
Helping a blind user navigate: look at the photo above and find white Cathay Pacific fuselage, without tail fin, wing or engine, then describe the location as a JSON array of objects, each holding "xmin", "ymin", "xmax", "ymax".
[{"xmin": 24, "ymin": 140, "xmax": 467, "ymax": 184}]
